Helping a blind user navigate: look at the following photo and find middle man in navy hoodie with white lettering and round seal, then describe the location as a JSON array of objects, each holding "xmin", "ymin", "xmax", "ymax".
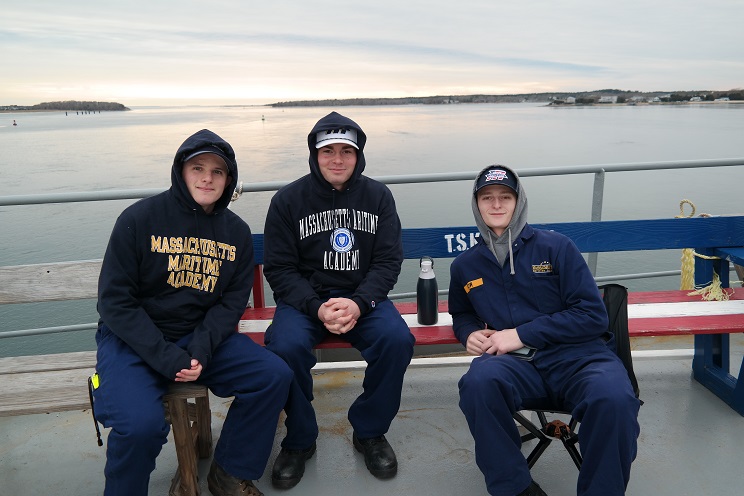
[{"xmin": 264, "ymin": 112, "xmax": 414, "ymax": 489}]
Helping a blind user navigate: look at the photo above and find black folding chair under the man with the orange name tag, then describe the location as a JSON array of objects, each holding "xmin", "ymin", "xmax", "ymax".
[{"xmin": 514, "ymin": 284, "xmax": 642, "ymax": 469}]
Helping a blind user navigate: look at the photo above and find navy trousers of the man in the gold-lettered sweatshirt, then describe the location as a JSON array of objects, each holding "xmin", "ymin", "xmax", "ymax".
[{"xmin": 95, "ymin": 326, "xmax": 292, "ymax": 496}]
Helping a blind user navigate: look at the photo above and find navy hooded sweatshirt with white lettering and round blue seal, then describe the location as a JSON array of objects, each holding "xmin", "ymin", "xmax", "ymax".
[{"xmin": 264, "ymin": 112, "xmax": 403, "ymax": 317}]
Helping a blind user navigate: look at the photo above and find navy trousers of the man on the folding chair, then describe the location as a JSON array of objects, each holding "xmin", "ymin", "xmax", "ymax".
[{"xmin": 459, "ymin": 347, "xmax": 640, "ymax": 496}]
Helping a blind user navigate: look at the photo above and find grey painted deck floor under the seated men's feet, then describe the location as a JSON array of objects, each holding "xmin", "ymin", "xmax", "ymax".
[{"xmin": 0, "ymin": 342, "xmax": 744, "ymax": 496}]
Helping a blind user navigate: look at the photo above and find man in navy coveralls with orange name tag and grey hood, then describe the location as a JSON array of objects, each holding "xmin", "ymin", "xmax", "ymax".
[{"xmin": 449, "ymin": 165, "xmax": 640, "ymax": 496}]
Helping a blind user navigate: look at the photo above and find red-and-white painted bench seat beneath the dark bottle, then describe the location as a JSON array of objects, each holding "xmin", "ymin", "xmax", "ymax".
[{"xmin": 238, "ymin": 288, "xmax": 744, "ymax": 349}]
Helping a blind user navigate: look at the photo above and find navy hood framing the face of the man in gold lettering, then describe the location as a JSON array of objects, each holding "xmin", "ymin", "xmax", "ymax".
[{"xmin": 171, "ymin": 129, "xmax": 238, "ymax": 212}]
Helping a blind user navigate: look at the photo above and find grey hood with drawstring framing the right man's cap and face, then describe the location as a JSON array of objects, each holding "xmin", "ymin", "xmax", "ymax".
[{"xmin": 471, "ymin": 164, "xmax": 527, "ymax": 275}]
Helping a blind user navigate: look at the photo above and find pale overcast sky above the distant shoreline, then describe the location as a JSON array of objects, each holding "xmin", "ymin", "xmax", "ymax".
[{"xmin": 0, "ymin": 0, "xmax": 744, "ymax": 106}]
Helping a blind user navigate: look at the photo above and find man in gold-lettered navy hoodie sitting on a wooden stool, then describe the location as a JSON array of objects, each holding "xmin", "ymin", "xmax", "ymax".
[{"xmin": 94, "ymin": 129, "xmax": 292, "ymax": 496}]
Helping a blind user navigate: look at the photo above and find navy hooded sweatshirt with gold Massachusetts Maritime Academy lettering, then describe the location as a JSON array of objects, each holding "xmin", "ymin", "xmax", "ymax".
[{"xmin": 98, "ymin": 129, "xmax": 254, "ymax": 380}]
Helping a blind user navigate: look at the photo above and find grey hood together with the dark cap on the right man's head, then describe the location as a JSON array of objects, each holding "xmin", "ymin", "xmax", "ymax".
[{"xmin": 470, "ymin": 164, "xmax": 527, "ymax": 274}]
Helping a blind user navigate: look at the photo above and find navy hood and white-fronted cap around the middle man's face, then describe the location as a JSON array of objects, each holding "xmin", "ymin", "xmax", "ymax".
[{"xmin": 307, "ymin": 112, "xmax": 367, "ymax": 189}]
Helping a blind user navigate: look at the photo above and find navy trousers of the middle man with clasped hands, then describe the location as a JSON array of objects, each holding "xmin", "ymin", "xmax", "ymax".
[{"xmin": 264, "ymin": 300, "xmax": 415, "ymax": 449}]
